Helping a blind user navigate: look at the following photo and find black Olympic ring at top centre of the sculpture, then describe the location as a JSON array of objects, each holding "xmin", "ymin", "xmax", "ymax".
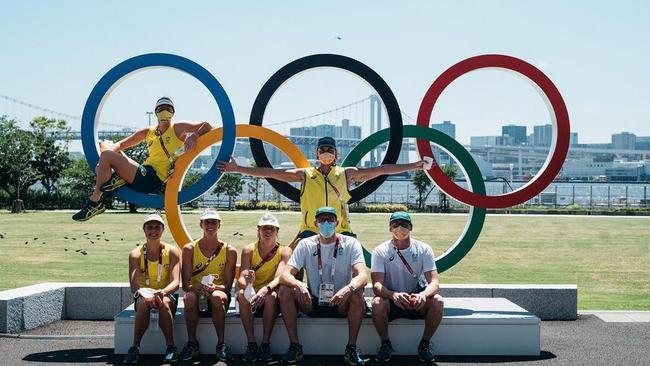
[{"xmin": 250, "ymin": 54, "xmax": 404, "ymax": 203}]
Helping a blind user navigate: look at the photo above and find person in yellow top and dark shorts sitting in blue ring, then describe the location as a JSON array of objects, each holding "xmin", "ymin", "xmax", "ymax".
[{"xmin": 72, "ymin": 97, "xmax": 212, "ymax": 221}]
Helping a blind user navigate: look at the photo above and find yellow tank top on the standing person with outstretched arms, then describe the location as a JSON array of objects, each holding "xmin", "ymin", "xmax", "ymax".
[{"xmin": 300, "ymin": 166, "xmax": 352, "ymax": 233}]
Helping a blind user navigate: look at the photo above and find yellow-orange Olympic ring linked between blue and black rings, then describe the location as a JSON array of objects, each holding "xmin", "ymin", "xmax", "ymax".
[{"xmin": 165, "ymin": 124, "xmax": 311, "ymax": 248}]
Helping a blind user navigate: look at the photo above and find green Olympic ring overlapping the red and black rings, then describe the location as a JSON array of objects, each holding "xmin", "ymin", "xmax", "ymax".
[{"xmin": 342, "ymin": 125, "xmax": 485, "ymax": 273}]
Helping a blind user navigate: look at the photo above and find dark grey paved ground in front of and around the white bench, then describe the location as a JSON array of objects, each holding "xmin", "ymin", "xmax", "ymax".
[{"xmin": 0, "ymin": 312, "xmax": 650, "ymax": 366}]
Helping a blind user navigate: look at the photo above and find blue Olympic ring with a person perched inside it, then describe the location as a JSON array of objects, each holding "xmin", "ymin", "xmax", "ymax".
[{"xmin": 81, "ymin": 53, "xmax": 236, "ymax": 208}]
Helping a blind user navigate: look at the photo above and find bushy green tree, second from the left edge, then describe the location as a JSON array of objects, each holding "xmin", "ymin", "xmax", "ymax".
[{"xmin": 29, "ymin": 116, "xmax": 71, "ymax": 194}]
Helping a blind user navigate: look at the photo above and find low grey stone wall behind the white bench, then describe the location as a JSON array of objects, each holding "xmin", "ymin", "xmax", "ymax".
[{"xmin": 0, "ymin": 282, "xmax": 578, "ymax": 333}]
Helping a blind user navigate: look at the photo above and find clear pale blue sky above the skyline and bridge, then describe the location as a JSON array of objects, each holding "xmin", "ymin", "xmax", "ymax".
[{"xmin": 0, "ymin": 1, "xmax": 650, "ymax": 142}]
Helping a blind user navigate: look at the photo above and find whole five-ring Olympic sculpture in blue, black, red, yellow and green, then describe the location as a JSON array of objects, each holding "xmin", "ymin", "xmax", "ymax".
[{"xmin": 81, "ymin": 53, "xmax": 570, "ymax": 272}]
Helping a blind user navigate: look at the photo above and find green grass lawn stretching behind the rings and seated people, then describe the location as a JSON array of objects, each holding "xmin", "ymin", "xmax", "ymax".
[{"xmin": 0, "ymin": 211, "xmax": 650, "ymax": 310}]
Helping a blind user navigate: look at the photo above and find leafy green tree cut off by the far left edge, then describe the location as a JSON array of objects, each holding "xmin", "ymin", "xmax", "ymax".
[{"xmin": 0, "ymin": 116, "xmax": 41, "ymax": 212}]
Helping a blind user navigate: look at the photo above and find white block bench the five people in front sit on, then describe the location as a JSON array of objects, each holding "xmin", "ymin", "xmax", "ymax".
[{"xmin": 115, "ymin": 297, "xmax": 540, "ymax": 356}]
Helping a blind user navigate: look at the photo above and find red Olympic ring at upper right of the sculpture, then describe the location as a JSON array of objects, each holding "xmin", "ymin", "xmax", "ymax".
[{"xmin": 417, "ymin": 55, "xmax": 570, "ymax": 208}]
